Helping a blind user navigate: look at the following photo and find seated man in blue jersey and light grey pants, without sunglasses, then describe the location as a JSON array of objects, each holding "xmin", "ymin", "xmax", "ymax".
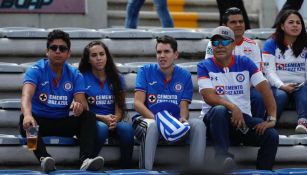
[{"xmin": 133, "ymin": 36, "xmax": 206, "ymax": 169}]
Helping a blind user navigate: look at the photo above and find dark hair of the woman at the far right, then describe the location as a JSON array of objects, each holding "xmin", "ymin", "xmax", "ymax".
[{"xmin": 273, "ymin": 10, "xmax": 307, "ymax": 57}]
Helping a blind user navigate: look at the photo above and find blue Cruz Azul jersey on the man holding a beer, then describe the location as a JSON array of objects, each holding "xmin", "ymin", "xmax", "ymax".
[{"xmin": 23, "ymin": 59, "xmax": 85, "ymax": 118}]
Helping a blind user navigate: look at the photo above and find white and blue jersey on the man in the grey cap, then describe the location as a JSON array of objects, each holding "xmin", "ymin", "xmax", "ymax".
[{"xmin": 197, "ymin": 55, "xmax": 265, "ymax": 116}]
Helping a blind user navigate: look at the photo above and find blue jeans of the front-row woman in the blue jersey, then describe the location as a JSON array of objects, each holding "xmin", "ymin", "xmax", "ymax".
[{"xmin": 96, "ymin": 121, "xmax": 134, "ymax": 168}]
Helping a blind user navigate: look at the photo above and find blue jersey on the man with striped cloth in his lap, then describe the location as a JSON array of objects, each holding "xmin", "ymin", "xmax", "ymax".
[{"xmin": 135, "ymin": 64, "xmax": 193, "ymax": 108}]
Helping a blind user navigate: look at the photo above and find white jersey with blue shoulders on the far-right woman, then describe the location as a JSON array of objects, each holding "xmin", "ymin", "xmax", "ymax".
[{"xmin": 262, "ymin": 38, "xmax": 307, "ymax": 88}]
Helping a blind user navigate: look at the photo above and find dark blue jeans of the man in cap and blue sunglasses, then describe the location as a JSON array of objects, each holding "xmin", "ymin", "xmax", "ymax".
[{"xmin": 204, "ymin": 105, "xmax": 279, "ymax": 170}]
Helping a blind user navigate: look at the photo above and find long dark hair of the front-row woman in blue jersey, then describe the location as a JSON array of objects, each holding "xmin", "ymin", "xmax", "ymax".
[{"xmin": 78, "ymin": 41, "xmax": 126, "ymax": 117}]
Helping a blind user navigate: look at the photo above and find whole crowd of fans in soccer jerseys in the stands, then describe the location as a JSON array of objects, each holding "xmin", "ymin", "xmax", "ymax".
[{"xmin": 16, "ymin": 0, "xmax": 307, "ymax": 173}]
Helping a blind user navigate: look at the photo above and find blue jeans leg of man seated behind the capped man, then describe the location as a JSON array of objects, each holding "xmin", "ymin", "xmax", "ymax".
[{"xmin": 250, "ymin": 87, "xmax": 266, "ymax": 120}]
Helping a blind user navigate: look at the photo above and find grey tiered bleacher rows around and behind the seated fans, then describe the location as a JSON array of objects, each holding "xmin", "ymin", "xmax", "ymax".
[{"xmin": 0, "ymin": 27, "xmax": 307, "ymax": 173}]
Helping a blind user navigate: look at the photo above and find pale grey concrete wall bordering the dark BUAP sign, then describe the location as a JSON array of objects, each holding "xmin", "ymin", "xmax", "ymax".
[{"xmin": 0, "ymin": 0, "xmax": 107, "ymax": 29}]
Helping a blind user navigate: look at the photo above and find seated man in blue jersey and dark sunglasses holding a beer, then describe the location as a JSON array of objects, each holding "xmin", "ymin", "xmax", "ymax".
[{"xmin": 19, "ymin": 30, "xmax": 104, "ymax": 173}]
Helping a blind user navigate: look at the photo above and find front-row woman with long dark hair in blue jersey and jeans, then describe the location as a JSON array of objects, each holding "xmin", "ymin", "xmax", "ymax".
[{"xmin": 79, "ymin": 41, "xmax": 134, "ymax": 168}]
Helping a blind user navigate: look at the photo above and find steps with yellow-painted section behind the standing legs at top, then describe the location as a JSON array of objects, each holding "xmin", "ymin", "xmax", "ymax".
[{"xmin": 107, "ymin": 0, "xmax": 259, "ymax": 28}]
